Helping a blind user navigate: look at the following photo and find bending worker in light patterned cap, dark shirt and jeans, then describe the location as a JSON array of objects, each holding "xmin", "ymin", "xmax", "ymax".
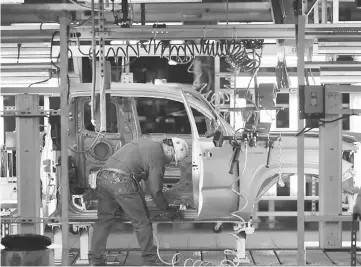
[{"xmin": 89, "ymin": 137, "xmax": 189, "ymax": 266}]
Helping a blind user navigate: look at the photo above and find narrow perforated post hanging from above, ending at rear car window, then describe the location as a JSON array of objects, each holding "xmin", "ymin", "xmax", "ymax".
[{"xmin": 98, "ymin": 0, "xmax": 107, "ymax": 132}]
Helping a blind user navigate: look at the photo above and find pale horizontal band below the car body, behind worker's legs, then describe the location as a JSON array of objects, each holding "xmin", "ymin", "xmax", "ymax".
[{"xmin": 60, "ymin": 224, "xmax": 351, "ymax": 249}]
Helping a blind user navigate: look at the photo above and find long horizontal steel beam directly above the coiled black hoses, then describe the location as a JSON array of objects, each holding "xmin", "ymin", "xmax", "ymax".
[{"xmin": 1, "ymin": 24, "xmax": 296, "ymax": 43}]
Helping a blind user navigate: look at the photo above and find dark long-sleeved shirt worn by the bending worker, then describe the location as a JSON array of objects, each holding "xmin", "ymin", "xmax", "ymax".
[{"xmin": 104, "ymin": 138, "xmax": 168, "ymax": 210}]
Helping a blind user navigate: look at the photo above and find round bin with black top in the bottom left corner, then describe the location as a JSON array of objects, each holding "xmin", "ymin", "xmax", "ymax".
[{"xmin": 1, "ymin": 234, "xmax": 54, "ymax": 266}]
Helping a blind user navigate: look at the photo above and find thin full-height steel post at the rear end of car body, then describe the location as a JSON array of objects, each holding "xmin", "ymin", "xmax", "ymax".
[{"xmin": 59, "ymin": 11, "xmax": 69, "ymax": 266}]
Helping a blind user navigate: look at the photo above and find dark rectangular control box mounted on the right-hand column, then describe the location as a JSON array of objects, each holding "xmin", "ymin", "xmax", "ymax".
[{"xmin": 299, "ymin": 85, "xmax": 325, "ymax": 119}]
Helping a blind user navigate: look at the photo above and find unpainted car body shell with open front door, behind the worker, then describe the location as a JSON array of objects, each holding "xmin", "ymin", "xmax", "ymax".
[{"xmin": 32, "ymin": 83, "xmax": 356, "ymax": 226}]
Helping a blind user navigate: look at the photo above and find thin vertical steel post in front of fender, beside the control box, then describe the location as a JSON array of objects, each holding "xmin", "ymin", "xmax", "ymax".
[{"xmin": 296, "ymin": 15, "xmax": 306, "ymax": 266}]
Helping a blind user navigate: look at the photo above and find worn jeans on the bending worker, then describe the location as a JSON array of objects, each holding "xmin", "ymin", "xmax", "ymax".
[{"xmin": 89, "ymin": 171, "xmax": 157, "ymax": 264}]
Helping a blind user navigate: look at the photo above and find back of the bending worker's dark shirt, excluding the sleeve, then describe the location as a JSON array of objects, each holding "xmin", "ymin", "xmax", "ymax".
[{"xmin": 105, "ymin": 138, "xmax": 166, "ymax": 180}]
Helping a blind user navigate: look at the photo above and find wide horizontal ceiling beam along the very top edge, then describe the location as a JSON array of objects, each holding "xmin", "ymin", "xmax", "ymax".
[{"xmin": 1, "ymin": 2, "xmax": 272, "ymax": 25}]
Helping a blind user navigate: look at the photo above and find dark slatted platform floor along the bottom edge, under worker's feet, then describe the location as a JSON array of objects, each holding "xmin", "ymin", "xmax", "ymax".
[{"xmin": 62, "ymin": 249, "xmax": 361, "ymax": 266}]
